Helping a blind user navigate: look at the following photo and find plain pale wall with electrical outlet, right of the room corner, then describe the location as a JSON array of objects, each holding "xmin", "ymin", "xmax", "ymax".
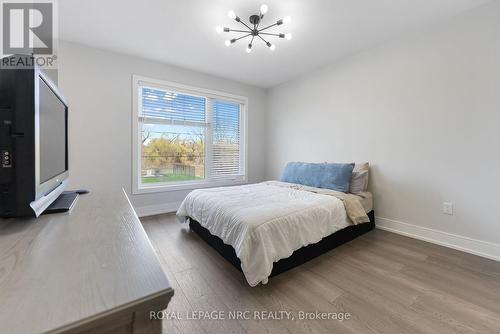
[{"xmin": 266, "ymin": 3, "xmax": 500, "ymax": 250}]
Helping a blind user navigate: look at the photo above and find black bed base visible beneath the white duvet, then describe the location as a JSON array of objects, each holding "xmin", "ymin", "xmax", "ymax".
[{"xmin": 189, "ymin": 210, "xmax": 375, "ymax": 277}]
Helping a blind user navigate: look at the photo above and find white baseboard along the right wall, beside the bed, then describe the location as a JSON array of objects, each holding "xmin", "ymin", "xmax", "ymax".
[{"xmin": 375, "ymin": 217, "xmax": 500, "ymax": 261}]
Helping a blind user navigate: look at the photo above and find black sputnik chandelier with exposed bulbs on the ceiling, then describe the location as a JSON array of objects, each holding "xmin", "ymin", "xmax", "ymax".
[{"xmin": 215, "ymin": 5, "xmax": 292, "ymax": 53}]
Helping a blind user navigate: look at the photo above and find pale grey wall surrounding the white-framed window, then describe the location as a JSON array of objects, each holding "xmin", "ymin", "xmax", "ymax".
[{"xmin": 58, "ymin": 41, "xmax": 267, "ymax": 213}]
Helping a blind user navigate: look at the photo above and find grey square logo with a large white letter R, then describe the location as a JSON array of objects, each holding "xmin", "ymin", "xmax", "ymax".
[{"xmin": 2, "ymin": 2, "xmax": 54, "ymax": 55}]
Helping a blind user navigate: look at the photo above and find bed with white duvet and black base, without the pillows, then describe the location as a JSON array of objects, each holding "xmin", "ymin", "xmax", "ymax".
[{"xmin": 177, "ymin": 177, "xmax": 375, "ymax": 286}]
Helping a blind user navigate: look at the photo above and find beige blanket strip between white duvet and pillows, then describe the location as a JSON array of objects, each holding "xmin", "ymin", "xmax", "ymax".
[{"xmin": 265, "ymin": 181, "xmax": 370, "ymax": 225}]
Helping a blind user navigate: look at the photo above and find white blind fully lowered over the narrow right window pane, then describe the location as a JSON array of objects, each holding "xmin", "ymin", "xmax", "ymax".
[{"xmin": 211, "ymin": 99, "xmax": 241, "ymax": 178}]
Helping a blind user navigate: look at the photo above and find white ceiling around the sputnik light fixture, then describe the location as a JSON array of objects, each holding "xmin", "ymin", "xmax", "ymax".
[{"xmin": 58, "ymin": 0, "xmax": 489, "ymax": 87}]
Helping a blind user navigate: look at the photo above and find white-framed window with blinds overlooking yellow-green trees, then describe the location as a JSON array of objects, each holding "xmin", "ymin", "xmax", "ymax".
[{"xmin": 133, "ymin": 76, "xmax": 247, "ymax": 193}]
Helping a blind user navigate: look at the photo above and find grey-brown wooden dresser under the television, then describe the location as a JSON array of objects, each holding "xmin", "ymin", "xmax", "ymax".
[{"xmin": 0, "ymin": 191, "xmax": 173, "ymax": 334}]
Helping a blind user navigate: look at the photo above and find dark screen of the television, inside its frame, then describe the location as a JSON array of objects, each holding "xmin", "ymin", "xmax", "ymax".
[{"xmin": 39, "ymin": 78, "xmax": 67, "ymax": 184}]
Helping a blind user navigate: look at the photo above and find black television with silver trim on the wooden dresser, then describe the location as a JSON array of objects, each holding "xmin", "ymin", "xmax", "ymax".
[{"xmin": 0, "ymin": 56, "xmax": 69, "ymax": 217}]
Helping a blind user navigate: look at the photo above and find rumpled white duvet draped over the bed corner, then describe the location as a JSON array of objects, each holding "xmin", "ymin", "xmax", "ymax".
[{"xmin": 177, "ymin": 181, "xmax": 351, "ymax": 286}]
